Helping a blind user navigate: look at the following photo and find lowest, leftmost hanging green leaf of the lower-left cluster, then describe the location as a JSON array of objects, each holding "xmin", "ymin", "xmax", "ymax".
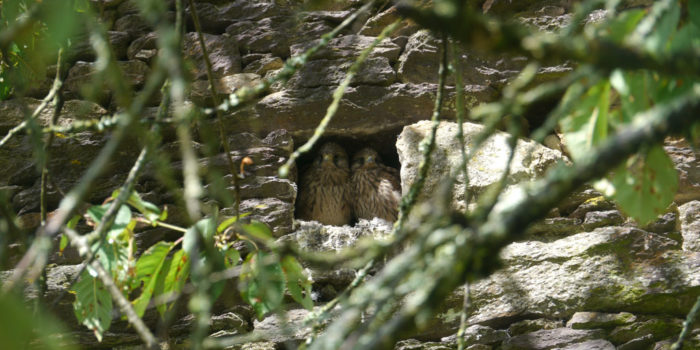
[{"xmin": 73, "ymin": 270, "xmax": 112, "ymax": 341}]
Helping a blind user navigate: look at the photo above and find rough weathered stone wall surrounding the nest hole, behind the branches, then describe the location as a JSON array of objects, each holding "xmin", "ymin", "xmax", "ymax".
[{"xmin": 0, "ymin": 0, "xmax": 700, "ymax": 349}]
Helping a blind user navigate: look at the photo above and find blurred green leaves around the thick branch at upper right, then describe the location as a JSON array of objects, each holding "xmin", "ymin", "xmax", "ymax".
[{"xmin": 560, "ymin": 1, "xmax": 700, "ymax": 225}]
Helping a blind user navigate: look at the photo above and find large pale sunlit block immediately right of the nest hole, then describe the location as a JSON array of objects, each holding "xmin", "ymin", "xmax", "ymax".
[{"xmin": 396, "ymin": 121, "xmax": 562, "ymax": 211}]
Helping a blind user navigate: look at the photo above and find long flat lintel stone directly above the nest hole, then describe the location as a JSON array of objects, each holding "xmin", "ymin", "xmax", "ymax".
[{"xmin": 225, "ymin": 84, "xmax": 470, "ymax": 139}]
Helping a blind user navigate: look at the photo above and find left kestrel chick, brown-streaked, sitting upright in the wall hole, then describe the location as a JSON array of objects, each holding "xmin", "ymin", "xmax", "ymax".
[{"xmin": 296, "ymin": 142, "xmax": 351, "ymax": 226}]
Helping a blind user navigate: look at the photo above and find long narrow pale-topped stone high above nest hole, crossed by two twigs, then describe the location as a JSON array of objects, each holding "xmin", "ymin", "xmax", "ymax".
[{"xmin": 290, "ymin": 35, "xmax": 401, "ymax": 64}]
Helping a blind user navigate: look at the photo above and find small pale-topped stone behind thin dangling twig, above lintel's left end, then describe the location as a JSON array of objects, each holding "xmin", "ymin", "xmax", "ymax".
[{"xmin": 189, "ymin": 73, "xmax": 260, "ymax": 107}]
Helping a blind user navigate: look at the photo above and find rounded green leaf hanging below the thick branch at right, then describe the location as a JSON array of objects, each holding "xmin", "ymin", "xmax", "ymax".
[{"xmin": 612, "ymin": 146, "xmax": 678, "ymax": 225}]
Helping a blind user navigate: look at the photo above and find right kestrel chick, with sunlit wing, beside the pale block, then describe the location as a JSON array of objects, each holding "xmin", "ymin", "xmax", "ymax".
[{"xmin": 350, "ymin": 148, "xmax": 401, "ymax": 222}]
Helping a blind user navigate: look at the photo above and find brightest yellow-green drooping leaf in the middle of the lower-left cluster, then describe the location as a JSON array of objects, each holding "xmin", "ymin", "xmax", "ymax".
[{"xmin": 133, "ymin": 241, "xmax": 173, "ymax": 317}]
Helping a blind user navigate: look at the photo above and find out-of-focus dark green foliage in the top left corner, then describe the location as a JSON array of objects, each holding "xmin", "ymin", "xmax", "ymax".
[{"xmin": 0, "ymin": 0, "xmax": 88, "ymax": 100}]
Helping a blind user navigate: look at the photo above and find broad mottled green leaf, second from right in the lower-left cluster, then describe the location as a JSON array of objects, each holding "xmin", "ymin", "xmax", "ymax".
[{"xmin": 239, "ymin": 251, "xmax": 285, "ymax": 320}]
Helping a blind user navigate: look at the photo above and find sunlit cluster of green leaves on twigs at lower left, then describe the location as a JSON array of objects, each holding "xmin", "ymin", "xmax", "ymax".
[{"xmin": 68, "ymin": 192, "xmax": 313, "ymax": 340}]
